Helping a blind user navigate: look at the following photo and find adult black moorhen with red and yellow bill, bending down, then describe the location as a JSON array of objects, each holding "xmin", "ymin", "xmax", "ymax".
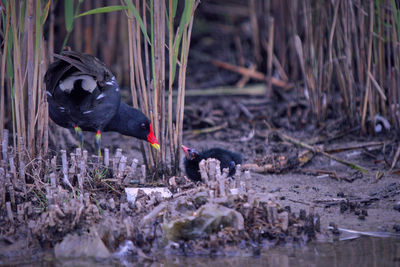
[{"xmin": 45, "ymin": 51, "xmax": 160, "ymax": 156}]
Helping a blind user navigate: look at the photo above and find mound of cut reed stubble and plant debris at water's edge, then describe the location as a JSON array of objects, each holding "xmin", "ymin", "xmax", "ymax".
[{"xmin": 0, "ymin": 149, "xmax": 321, "ymax": 262}]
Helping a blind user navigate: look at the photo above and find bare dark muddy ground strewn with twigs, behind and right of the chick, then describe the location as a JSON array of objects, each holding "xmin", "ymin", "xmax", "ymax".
[{"xmin": 107, "ymin": 96, "xmax": 400, "ymax": 232}]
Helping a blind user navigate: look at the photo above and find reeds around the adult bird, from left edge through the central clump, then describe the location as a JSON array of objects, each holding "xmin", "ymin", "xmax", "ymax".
[{"xmin": 0, "ymin": 0, "xmax": 198, "ymax": 180}]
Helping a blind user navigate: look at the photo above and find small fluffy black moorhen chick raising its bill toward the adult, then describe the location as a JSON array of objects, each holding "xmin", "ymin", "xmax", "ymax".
[{"xmin": 182, "ymin": 146, "xmax": 242, "ymax": 182}]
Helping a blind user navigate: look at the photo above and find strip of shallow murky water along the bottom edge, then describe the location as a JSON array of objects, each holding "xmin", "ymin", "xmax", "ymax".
[{"xmin": 0, "ymin": 236, "xmax": 400, "ymax": 267}]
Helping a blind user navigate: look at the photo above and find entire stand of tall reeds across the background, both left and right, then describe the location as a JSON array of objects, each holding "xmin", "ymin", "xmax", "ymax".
[{"xmin": 0, "ymin": 0, "xmax": 400, "ymax": 180}]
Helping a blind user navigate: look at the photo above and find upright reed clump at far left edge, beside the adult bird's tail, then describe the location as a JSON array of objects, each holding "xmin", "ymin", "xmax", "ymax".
[{"xmin": 0, "ymin": 0, "xmax": 51, "ymax": 162}]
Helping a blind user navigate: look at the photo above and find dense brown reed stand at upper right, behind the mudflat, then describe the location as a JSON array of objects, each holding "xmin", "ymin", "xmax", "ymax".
[{"xmin": 255, "ymin": 0, "xmax": 400, "ymax": 133}]
